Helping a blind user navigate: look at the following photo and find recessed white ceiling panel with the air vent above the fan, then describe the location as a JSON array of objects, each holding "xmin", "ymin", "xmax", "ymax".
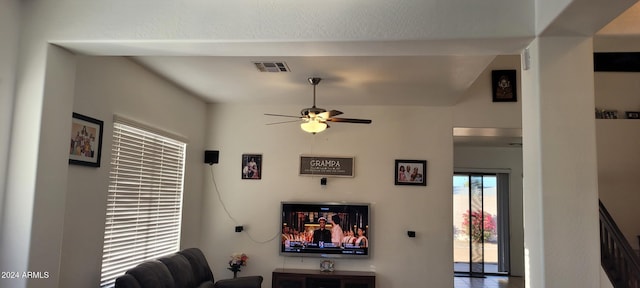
[{"xmin": 135, "ymin": 55, "xmax": 494, "ymax": 108}]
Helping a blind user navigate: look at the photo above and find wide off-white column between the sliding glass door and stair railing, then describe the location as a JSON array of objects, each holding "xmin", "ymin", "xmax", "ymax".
[{"xmin": 522, "ymin": 37, "xmax": 600, "ymax": 287}]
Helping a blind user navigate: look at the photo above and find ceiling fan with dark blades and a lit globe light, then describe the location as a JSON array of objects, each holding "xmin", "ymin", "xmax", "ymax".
[{"xmin": 264, "ymin": 77, "xmax": 371, "ymax": 134}]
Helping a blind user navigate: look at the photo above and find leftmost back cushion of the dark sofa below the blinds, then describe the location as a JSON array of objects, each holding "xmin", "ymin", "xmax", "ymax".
[{"xmin": 126, "ymin": 260, "xmax": 176, "ymax": 288}]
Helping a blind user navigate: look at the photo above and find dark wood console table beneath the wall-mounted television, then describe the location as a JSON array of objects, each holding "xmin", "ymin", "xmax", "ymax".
[{"xmin": 271, "ymin": 268, "xmax": 376, "ymax": 288}]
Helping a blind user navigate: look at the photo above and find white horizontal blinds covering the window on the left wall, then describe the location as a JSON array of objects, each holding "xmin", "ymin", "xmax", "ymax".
[{"xmin": 100, "ymin": 120, "xmax": 186, "ymax": 287}]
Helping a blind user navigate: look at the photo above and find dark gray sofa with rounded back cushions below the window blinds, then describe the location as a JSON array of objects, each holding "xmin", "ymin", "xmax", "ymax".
[{"xmin": 115, "ymin": 248, "xmax": 263, "ymax": 288}]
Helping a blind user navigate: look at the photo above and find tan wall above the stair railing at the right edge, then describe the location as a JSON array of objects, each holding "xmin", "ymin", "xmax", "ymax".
[{"xmin": 595, "ymin": 72, "xmax": 640, "ymax": 249}]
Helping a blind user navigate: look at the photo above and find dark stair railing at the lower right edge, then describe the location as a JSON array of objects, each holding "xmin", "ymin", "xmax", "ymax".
[{"xmin": 600, "ymin": 201, "xmax": 640, "ymax": 288}]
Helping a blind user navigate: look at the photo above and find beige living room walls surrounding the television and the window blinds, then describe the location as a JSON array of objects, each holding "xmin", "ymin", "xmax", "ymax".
[{"xmin": 55, "ymin": 53, "xmax": 524, "ymax": 287}]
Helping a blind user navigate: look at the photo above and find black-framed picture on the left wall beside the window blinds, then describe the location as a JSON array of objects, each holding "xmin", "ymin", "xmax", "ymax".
[{"xmin": 69, "ymin": 113, "xmax": 104, "ymax": 167}]
